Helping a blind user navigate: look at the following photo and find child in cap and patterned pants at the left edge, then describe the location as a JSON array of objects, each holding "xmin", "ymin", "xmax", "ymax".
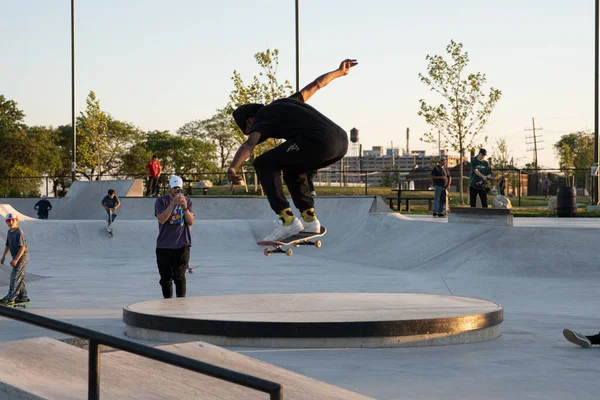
[{"xmin": 0, "ymin": 213, "xmax": 29, "ymax": 306}]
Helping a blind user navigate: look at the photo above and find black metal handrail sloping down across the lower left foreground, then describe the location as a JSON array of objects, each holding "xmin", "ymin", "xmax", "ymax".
[{"xmin": 0, "ymin": 306, "xmax": 283, "ymax": 400}]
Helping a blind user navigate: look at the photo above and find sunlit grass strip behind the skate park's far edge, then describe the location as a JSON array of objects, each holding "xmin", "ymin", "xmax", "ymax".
[{"xmin": 193, "ymin": 185, "xmax": 600, "ymax": 218}]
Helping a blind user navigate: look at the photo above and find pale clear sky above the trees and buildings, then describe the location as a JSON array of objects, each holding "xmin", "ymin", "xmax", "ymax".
[{"xmin": 0, "ymin": 0, "xmax": 594, "ymax": 167}]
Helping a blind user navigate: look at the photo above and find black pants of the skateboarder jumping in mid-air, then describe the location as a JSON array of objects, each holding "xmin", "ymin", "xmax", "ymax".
[{"xmin": 254, "ymin": 129, "xmax": 348, "ymax": 214}]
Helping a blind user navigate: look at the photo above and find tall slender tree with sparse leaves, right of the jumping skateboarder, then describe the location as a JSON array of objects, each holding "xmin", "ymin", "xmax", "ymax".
[{"xmin": 418, "ymin": 40, "xmax": 502, "ymax": 204}]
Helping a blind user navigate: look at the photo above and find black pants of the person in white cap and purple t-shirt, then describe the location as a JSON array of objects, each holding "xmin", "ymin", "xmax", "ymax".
[{"xmin": 156, "ymin": 247, "xmax": 190, "ymax": 299}]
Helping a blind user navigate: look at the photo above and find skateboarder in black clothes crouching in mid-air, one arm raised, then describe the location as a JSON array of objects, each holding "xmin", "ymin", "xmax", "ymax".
[{"xmin": 227, "ymin": 59, "xmax": 358, "ymax": 241}]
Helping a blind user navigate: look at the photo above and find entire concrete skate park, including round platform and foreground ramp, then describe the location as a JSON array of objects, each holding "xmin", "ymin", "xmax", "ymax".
[{"xmin": 0, "ymin": 181, "xmax": 600, "ymax": 399}]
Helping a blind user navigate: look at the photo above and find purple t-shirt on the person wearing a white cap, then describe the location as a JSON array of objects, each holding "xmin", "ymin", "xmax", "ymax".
[{"xmin": 154, "ymin": 195, "xmax": 194, "ymax": 249}]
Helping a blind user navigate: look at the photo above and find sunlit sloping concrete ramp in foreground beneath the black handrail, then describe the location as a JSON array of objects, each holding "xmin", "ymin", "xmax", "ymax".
[{"xmin": 0, "ymin": 338, "xmax": 369, "ymax": 400}]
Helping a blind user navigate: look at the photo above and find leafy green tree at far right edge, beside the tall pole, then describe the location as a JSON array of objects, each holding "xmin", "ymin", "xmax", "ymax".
[{"xmin": 554, "ymin": 131, "xmax": 594, "ymax": 189}]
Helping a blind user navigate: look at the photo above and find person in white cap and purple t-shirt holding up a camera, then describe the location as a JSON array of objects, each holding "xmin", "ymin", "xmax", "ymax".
[{"xmin": 154, "ymin": 176, "xmax": 194, "ymax": 299}]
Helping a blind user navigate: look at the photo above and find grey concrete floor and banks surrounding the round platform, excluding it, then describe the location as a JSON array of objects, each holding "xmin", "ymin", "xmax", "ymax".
[{"xmin": 0, "ymin": 196, "xmax": 600, "ymax": 400}]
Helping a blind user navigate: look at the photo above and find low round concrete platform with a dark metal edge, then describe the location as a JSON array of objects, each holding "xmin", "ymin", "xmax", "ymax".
[{"xmin": 123, "ymin": 293, "xmax": 503, "ymax": 348}]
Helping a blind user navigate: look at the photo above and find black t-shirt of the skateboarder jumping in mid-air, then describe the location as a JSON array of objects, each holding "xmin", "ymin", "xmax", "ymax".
[{"xmin": 250, "ymin": 92, "xmax": 345, "ymax": 143}]
